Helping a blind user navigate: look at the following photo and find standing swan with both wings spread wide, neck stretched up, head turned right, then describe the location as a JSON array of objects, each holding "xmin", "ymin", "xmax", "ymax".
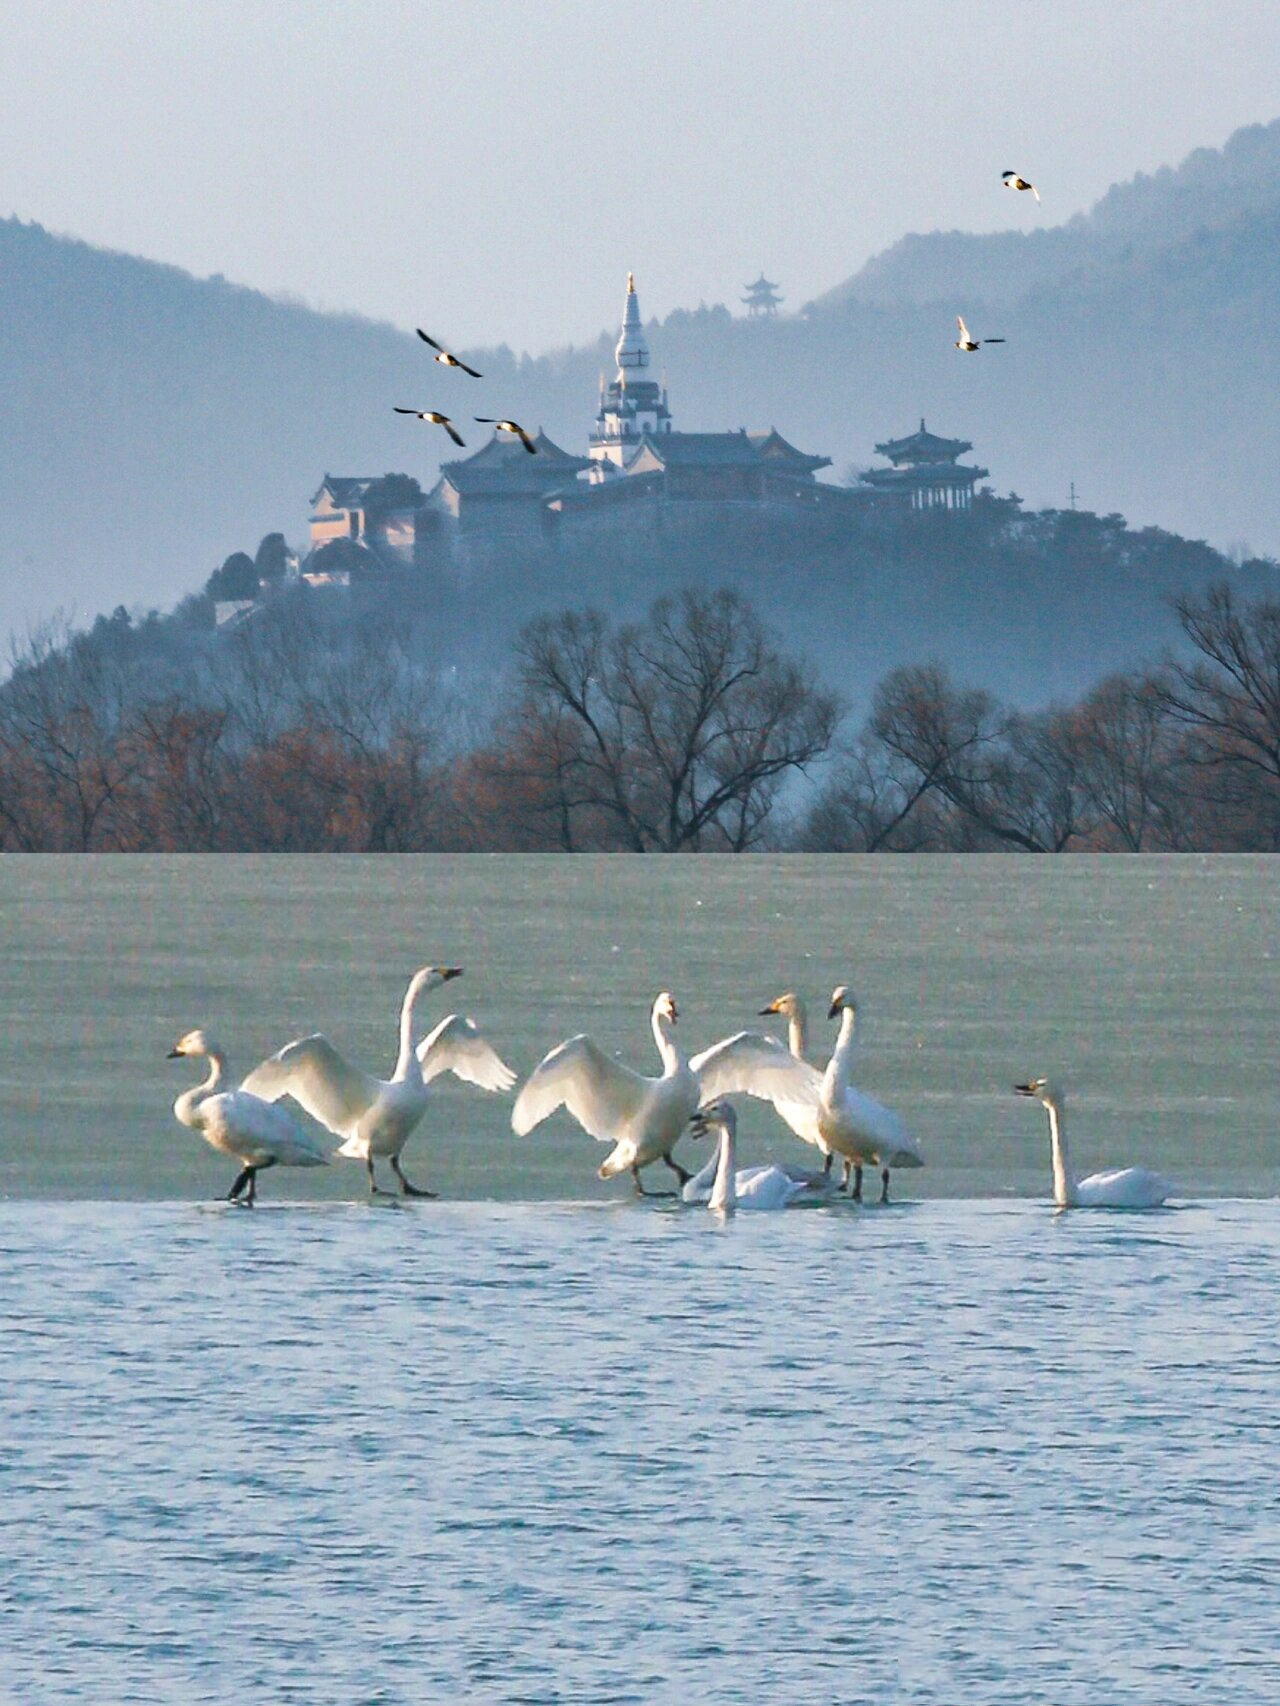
[{"xmin": 244, "ymin": 966, "xmax": 515, "ymax": 1196}]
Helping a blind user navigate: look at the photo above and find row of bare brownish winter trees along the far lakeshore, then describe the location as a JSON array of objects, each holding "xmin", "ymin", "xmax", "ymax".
[{"xmin": 0, "ymin": 582, "xmax": 1280, "ymax": 853}]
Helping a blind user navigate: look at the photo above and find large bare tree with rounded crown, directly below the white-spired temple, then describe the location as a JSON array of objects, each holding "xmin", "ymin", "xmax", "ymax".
[{"xmin": 505, "ymin": 592, "xmax": 840, "ymax": 853}]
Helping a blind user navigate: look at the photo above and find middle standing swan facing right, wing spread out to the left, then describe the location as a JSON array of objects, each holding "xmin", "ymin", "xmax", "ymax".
[{"xmin": 510, "ymin": 989, "xmax": 701, "ymax": 1196}]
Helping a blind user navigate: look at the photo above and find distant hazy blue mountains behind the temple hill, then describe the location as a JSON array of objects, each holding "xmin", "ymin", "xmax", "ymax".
[{"xmin": 0, "ymin": 123, "xmax": 1280, "ymax": 653}]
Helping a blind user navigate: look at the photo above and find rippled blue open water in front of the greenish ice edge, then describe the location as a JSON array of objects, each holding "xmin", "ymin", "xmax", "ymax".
[{"xmin": 0, "ymin": 1201, "xmax": 1280, "ymax": 1706}]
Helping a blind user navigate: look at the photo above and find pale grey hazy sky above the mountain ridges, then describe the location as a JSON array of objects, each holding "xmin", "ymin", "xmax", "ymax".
[{"xmin": 0, "ymin": 0, "xmax": 1280, "ymax": 351}]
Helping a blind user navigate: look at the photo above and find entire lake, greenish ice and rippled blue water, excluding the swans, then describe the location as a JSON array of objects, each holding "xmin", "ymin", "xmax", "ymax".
[{"xmin": 0, "ymin": 856, "xmax": 1280, "ymax": 1706}]
